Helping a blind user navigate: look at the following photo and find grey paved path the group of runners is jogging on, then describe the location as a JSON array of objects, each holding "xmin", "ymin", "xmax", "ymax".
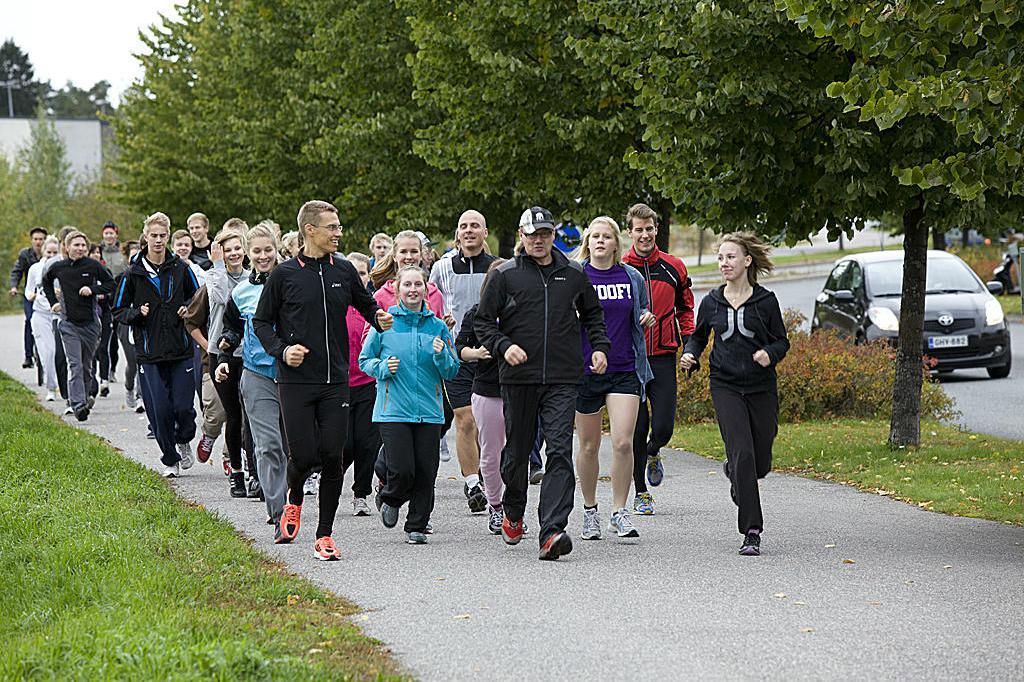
[{"xmin": 0, "ymin": 316, "xmax": 1024, "ymax": 680}]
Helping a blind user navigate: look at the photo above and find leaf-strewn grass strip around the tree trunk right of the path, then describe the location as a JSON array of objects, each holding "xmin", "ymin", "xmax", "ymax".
[{"xmin": 671, "ymin": 419, "xmax": 1024, "ymax": 524}]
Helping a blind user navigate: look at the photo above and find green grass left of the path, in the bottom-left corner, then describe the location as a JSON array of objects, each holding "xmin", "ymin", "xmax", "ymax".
[{"xmin": 0, "ymin": 374, "xmax": 397, "ymax": 680}]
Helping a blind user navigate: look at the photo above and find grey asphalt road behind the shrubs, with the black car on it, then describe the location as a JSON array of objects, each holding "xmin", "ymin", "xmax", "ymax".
[{"xmin": 694, "ymin": 274, "xmax": 1024, "ymax": 440}]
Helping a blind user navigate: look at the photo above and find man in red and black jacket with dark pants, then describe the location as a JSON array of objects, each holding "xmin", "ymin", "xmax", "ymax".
[{"xmin": 623, "ymin": 204, "xmax": 693, "ymax": 515}]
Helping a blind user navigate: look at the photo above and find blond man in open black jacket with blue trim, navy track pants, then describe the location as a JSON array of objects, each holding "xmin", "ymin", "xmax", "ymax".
[{"xmin": 114, "ymin": 212, "xmax": 199, "ymax": 478}]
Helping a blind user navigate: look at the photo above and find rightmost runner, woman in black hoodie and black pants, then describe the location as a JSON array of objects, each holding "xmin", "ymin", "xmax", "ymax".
[{"xmin": 679, "ymin": 232, "xmax": 790, "ymax": 556}]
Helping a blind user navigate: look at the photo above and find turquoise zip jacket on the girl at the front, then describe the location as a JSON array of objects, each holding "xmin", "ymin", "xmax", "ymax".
[{"xmin": 359, "ymin": 304, "xmax": 459, "ymax": 424}]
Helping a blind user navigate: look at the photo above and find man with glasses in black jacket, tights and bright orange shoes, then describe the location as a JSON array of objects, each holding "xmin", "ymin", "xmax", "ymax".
[{"xmin": 253, "ymin": 201, "xmax": 392, "ymax": 561}]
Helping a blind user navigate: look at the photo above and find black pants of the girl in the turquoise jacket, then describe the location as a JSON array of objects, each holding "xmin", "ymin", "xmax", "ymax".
[{"xmin": 378, "ymin": 422, "xmax": 441, "ymax": 532}]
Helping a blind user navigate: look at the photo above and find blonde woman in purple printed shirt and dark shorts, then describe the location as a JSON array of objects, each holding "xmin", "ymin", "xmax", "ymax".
[{"xmin": 575, "ymin": 216, "xmax": 655, "ymax": 540}]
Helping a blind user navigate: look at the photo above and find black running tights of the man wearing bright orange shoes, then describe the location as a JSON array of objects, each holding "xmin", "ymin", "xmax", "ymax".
[{"xmin": 278, "ymin": 383, "xmax": 348, "ymax": 538}]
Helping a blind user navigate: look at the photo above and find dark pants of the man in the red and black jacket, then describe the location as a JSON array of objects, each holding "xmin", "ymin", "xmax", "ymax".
[{"xmin": 633, "ymin": 353, "xmax": 676, "ymax": 495}]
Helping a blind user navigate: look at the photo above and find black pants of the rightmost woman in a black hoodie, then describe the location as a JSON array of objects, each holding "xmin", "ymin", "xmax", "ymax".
[{"xmin": 711, "ymin": 388, "xmax": 778, "ymax": 535}]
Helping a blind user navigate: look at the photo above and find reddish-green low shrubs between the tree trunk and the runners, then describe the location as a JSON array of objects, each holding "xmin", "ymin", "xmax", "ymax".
[{"xmin": 676, "ymin": 310, "xmax": 954, "ymax": 423}]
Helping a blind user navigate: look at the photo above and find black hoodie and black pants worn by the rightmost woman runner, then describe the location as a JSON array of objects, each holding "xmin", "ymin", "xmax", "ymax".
[{"xmin": 683, "ymin": 285, "xmax": 790, "ymax": 534}]
